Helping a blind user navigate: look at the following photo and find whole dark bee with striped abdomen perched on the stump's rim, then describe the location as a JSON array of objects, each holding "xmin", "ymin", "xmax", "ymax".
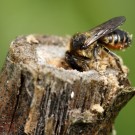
[{"xmin": 65, "ymin": 16, "xmax": 132, "ymax": 72}]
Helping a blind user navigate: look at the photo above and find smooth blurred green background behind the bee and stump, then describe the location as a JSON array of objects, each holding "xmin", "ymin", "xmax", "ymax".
[{"xmin": 0, "ymin": 0, "xmax": 135, "ymax": 135}]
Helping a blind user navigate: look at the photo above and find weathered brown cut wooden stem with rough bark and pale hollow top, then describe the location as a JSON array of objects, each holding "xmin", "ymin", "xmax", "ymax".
[{"xmin": 0, "ymin": 35, "xmax": 135, "ymax": 135}]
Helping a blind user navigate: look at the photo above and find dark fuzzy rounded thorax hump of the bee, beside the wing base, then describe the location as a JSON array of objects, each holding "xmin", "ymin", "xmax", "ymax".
[{"xmin": 70, "ymin": 33, "xmax": 86, "ymax": 50}]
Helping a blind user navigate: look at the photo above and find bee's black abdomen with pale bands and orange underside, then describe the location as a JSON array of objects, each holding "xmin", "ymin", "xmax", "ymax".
[{"xmin": 98, "ymin": 29, "xmax": 132, "ymax": 50}]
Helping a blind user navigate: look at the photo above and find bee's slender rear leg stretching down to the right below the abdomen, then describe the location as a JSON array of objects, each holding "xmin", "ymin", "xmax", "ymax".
[{"xmin": 102, "ymin": 46, "xmax": 123, "ymax": 73}]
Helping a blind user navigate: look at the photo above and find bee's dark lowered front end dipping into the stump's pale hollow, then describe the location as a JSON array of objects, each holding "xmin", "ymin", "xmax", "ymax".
[{"xmin": 65, "ymin": 51, "xmax": 89, "ymax": 72}]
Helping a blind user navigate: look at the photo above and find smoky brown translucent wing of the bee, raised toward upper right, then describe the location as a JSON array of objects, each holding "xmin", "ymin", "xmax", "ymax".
[{"xmin": 82, "ymin": 16, "xmax": 126, "ymax": 48}]
